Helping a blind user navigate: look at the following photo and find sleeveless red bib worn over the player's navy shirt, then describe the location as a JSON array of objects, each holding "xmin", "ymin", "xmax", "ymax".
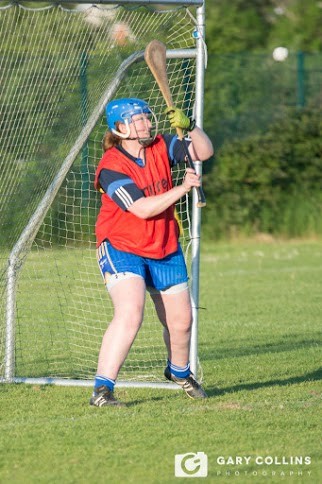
[{"xmin": 94, "ymin": 136, "xmax": 179, "ymax": 259}]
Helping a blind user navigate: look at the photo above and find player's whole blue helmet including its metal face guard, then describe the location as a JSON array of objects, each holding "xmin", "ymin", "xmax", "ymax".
[{"xmin": 105, "ymin": 98, "xmax": 158, "ymax": 146}]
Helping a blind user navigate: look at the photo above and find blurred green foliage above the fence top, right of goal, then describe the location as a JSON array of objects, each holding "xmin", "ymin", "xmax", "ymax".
[{"xmin": 206, "ymin": 0, "xmax": 322, "ymax": 54}]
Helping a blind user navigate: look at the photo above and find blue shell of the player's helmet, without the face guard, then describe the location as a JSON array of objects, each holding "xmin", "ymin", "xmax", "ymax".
[{"xmin": 105, "ymin": 97, "xmax": 152, "ymax": 130}]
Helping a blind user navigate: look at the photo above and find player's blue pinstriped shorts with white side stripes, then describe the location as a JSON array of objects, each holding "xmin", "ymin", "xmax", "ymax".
[{"xmin": 97, "ymin": 241, "xmax": 188, "ymax": 291}]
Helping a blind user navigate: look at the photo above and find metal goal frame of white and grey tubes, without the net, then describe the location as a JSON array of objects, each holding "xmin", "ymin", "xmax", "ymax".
[{"xmin": 0, "ymin": 0, "xmax": 206, "ymax": 389}]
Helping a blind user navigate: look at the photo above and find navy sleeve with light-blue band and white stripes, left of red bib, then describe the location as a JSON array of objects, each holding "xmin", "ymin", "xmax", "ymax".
[{"xmin": 99, "ymin": 168, "xmax": 144, "ymax": 210}]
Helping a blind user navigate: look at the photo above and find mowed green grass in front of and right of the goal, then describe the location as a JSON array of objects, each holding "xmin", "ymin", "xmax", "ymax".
[{"xmin": 0, "ymin": 241, "xmax": 322, "ymax": 484}]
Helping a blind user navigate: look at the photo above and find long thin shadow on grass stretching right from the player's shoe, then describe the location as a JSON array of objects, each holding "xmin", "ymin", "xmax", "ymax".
[{"xmin": 207, "ymin": 368, "xmax": 322, "ymax": 397}]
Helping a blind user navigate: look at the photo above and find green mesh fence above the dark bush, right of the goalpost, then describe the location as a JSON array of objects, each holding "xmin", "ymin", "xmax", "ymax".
[{"xmin": 204, "ymin": 52, "xmax": 322, "ymax": 153}]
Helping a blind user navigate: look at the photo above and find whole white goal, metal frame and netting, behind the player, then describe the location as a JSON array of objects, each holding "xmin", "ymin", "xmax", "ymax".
[{"xmin": 0, "ymin": 0, "xmax": 206, "ymax": 388}]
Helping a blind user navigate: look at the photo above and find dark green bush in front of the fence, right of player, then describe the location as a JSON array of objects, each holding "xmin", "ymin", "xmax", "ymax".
[{"xmin": 204, "ymin": 109, "xmax": 322, "ymax": 238}]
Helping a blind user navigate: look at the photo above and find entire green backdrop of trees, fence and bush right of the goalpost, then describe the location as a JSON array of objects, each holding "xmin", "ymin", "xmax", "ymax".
[{"xmin": 203, "ymin": 0, "xmax": 322, "ymax": 239}]
